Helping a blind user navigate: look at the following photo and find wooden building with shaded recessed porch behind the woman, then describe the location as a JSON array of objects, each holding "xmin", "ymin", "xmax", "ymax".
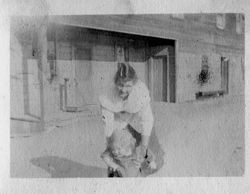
[{"xmin": 10, "ymin": 14, "xmax": 244, "ymax": 134}]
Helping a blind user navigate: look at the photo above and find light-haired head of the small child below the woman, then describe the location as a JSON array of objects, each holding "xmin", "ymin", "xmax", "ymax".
[{"xmin": 109, "ymin": 126, "xmax": 136, "ymax": 157}]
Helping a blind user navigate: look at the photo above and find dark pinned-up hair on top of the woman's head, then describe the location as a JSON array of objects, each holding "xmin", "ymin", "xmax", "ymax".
[{"xmin": 114, "ymin": 63, "xmax": 138, "ymax": 85}]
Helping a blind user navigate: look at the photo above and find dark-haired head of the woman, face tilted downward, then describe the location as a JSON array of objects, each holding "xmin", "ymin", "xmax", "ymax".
[{"xmin": 114, "ymin": 63, "xmax": 138, "ymax": 98}]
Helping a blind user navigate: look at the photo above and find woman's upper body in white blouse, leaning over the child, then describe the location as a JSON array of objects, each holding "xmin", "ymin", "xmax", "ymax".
[{"xmin": 100, "ymin": 63, "xmax": 164, "ymax": 177}]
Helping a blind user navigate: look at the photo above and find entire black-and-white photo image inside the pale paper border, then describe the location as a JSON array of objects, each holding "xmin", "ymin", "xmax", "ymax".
[{"xmin": 10, "ymin": 13, "xmax": 245, "ymax": 178}]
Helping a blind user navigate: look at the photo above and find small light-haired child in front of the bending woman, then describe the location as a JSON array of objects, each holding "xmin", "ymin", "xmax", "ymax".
[{"xmin": 101, "ymin": 125, "xmax": 156, "ymax": 177}]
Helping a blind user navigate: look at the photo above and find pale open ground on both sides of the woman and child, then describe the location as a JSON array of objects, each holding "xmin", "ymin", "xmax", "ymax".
[{"xmin": 10, "ymin": 97, "xmax": 245, "ymax": 177}]
